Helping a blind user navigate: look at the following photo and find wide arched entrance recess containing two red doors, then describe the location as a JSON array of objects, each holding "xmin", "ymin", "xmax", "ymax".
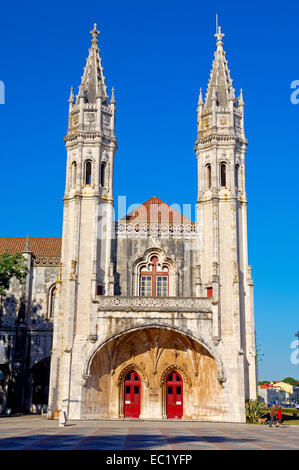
[{"xmin": 81, "ymin": 326, "xmax": 224, "ymax": 420}]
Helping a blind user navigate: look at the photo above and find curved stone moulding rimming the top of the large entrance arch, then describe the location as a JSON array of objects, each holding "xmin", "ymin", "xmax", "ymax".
[{"xmin": 82, "ymin": 323, "xmax": 226, "ymax": 384}]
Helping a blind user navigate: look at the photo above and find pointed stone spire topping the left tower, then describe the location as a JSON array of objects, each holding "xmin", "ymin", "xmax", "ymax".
[{"xmin": 77, "ymin": 23, "xmax": 108, "ymax": 103}]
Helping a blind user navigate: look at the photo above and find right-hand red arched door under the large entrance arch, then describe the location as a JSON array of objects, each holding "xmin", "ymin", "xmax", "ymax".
[{"xmin": 166, "ymin": 372, "xmax": 183, "ymax": 418}]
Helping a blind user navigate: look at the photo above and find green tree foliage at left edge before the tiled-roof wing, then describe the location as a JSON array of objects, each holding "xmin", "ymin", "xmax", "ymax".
[{"xmin": 0, "ymin": 250, "xmax": 28, "ymax": 296}]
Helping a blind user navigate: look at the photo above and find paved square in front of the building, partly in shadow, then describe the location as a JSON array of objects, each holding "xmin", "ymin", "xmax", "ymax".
[{"xmin": 0, "ymin": 415, "xmax": 299, "ymax": 451}]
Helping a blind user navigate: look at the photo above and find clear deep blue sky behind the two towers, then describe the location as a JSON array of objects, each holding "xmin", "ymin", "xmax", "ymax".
[{"xmin": 0, "ymin": 0, "xmax": 299, "ymax": 380}]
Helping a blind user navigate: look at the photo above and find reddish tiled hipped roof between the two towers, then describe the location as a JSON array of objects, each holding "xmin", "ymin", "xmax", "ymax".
[{"xmin": 121, "ymin": 196, "xmax": 193, "ymax": 224}]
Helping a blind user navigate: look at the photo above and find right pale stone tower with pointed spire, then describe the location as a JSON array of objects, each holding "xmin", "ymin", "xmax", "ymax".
[{"xmin": 195, "ymin": 27, "xmax": 256, "ymax": 408}]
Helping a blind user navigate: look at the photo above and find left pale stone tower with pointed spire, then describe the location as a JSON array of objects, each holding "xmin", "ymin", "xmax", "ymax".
[{"xmin": 49, "ymin": 24, "xmax": 117, "ymax": 415}]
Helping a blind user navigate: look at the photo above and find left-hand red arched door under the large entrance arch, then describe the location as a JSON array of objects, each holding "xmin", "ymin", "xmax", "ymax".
[{"xmin": 124, "ymin": 371, "xmax": 141, "ymax": 418}]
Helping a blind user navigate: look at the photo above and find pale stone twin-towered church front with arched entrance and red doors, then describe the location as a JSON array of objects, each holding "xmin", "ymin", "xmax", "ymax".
[{"xmin": 0, "ymin": 25, "xmax": 256, "ymax": 422}]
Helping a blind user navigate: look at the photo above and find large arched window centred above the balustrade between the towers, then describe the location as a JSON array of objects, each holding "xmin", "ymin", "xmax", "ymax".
[{"xmin": 140, "ymin": 256, "xmax": 169, "ymax": 297}]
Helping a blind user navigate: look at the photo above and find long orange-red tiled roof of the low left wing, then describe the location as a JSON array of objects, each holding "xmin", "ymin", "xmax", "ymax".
[{"xmin": 0, "ymin": 237, "xmax": 61, "ymax": 256}]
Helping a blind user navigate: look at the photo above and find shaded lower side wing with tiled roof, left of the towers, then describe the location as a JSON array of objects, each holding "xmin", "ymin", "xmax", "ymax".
[{"xmin": 0, "ymin": 237, "xmax": 61, "ymax": 413}]
